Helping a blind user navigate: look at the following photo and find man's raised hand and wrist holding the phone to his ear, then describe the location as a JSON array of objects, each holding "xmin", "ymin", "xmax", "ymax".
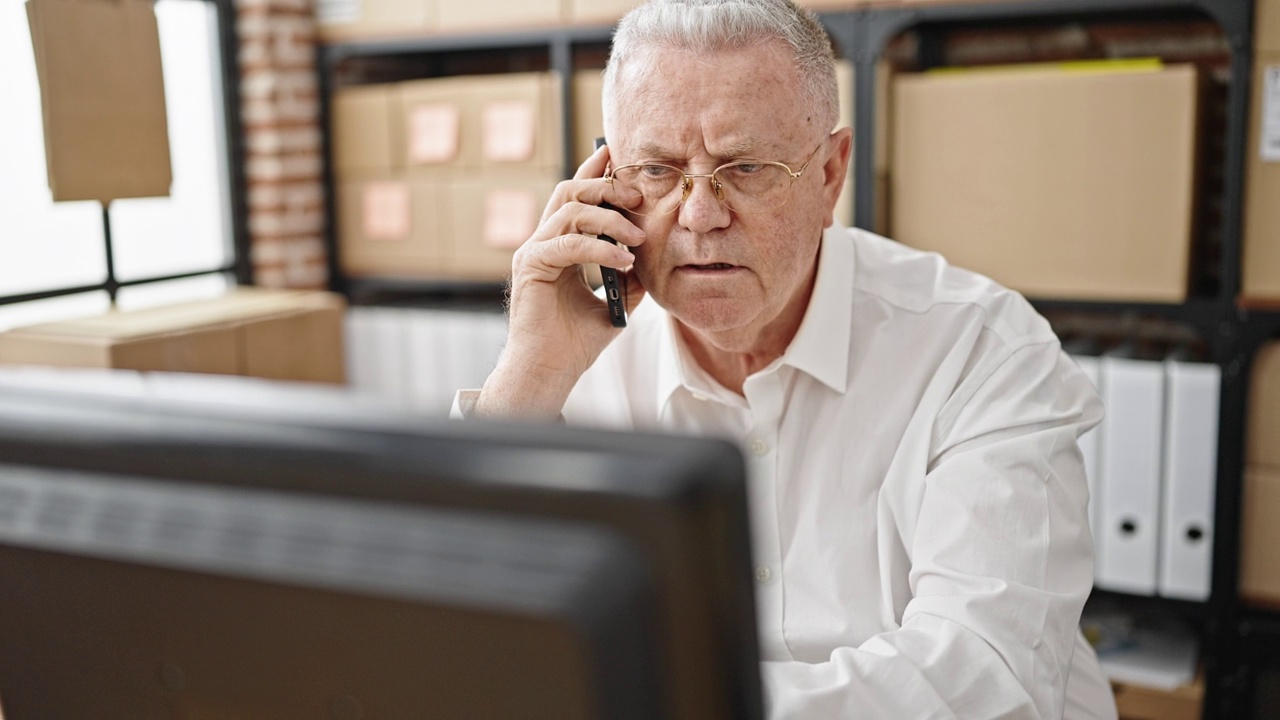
[{"xmin": 474, "ymin": 142, "xmax": 645, "ymax": 418}]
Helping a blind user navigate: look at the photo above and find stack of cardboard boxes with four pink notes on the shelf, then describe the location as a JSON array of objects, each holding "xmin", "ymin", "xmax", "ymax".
[{"xmin": 333, "ymin": 72, "xmax": 563, "ymax": 281}]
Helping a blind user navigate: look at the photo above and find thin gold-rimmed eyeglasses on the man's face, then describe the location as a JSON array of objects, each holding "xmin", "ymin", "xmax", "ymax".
[{"xmin": 604, "ymin": 142, "xmax": 822, "ymax": 215}]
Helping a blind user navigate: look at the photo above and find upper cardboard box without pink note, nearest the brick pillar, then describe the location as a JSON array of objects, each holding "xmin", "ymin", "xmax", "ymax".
[{"xmin": 330, "ymin": 85, "xmax": 402, "ymax": 179}]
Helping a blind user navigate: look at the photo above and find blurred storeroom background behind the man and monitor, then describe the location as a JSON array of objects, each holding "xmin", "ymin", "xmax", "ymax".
[{"xmin": 0, "ymin": 0, "xmax": 1280, "ymax": 720}]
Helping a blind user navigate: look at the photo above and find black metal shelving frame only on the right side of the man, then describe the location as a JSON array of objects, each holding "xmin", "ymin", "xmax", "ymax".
[{"xmin": 828, "ymin": 0, "xmax": 1259, "ymax": 720}]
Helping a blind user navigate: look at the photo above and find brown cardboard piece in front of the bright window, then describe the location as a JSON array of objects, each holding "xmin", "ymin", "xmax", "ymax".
[{"xmin": 27, "ymin": 0, "xmax": 173, "ymax": 204}]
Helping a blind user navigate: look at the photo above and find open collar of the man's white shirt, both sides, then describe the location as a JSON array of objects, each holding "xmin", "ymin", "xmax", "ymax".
[{"xmin": 657, "ymin": 223, "xmax": 854, "ymax": 415}]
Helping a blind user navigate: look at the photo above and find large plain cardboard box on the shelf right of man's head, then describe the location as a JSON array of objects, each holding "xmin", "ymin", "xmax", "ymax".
[{"xmin": 891, "ymin": 64, "xmax": 1199, "ymax": 302}]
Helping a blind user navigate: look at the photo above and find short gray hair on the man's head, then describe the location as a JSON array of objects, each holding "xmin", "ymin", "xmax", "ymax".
[{"xmin": 604, "ymin": 0, "xmax": 840, "ymax": 131}]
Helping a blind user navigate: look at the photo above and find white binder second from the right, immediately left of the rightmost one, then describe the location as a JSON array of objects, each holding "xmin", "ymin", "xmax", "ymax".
[{"xmin": 1094, "ymin": 355, "xmax": 1165, "ymax": 594}]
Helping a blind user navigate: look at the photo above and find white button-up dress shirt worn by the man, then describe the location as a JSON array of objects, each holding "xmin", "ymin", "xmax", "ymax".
[{"xmin": 460, "ymin": 227, "xmax": 1116, "ymax": 720}]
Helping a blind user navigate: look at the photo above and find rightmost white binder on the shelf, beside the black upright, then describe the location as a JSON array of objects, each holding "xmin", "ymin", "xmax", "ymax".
[{"xmin": 1160, "ymin": 360, "xmax": 1221, "ymax": 600}]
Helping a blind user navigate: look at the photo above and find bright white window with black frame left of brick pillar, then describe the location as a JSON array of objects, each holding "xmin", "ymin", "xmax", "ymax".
[{"xmin": 0, "ymin": 0, "xmax": 244, "ymax": 331}]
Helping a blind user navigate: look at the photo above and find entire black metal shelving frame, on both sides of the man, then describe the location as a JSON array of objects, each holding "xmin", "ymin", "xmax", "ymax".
[{"xmin": 319, "ymin": 0, "xmax": 1280, "ymax": 720}]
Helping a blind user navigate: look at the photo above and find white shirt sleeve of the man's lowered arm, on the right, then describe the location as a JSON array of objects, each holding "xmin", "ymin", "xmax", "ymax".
[{"xmin": 763, "ymin": 342, "xmax": 1102, "ymax": 720}]
